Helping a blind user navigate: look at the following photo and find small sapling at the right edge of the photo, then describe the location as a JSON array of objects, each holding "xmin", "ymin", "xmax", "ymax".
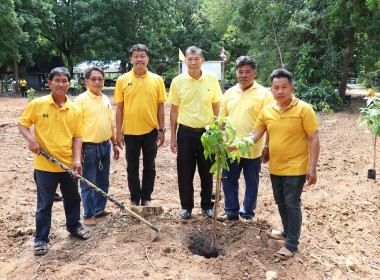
[{"xmin": 358, "ymin": 98, "xmax": 380, "ymax": 179}]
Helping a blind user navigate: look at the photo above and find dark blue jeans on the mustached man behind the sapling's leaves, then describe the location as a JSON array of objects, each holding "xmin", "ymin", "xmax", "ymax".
[{"xmin": 222, "ymin": 157, "xmax": 261, "ymax": 217}]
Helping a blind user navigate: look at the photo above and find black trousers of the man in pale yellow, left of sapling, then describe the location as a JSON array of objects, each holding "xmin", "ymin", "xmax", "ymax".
[{"xmin": 177, "ymin": 126, "xmax": 213, "ymax": 210}]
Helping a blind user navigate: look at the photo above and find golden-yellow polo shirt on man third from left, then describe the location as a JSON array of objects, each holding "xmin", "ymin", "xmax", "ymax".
[{"xmin": 114, "ymin": 70, "xmax": 166, "ymax": 135}]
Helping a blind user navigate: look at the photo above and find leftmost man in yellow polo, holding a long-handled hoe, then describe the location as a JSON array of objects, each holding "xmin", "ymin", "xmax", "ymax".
[{"xmin": 18, "ymin": 67, "xmax": 91, "ymax": 255}]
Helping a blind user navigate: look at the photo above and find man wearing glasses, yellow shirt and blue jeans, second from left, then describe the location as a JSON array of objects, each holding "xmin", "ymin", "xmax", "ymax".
[{"xmin": 75, "ymin": 66, "xmax": 119, "ymax": 225}]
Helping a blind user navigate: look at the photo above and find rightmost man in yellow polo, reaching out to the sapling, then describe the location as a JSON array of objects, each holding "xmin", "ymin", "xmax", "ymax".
[{"xmin": 230, "ymin": 69, "xmax": 319, "ymax": 259}]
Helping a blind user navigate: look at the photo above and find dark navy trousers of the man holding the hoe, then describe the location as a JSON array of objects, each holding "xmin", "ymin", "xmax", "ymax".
[{"xmin": 34, "ymin": 169, "xmax": 82, "ymax": 243}]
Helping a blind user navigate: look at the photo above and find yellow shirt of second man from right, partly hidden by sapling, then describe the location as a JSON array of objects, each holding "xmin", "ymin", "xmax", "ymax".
[{"xmin": 219, "ymin": 82, "xmax": 274, "ymax": 159}]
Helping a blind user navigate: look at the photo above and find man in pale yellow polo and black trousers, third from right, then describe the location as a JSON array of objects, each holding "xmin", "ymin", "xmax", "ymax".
[{"xmin": 169, "ymin": 46, "xmax": 222, "ymax": 220}]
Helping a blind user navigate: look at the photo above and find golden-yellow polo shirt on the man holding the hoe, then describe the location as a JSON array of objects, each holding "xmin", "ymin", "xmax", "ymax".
[{"xmin": 19, "ymin": 94, "xmax": 82, "ymax": 172}]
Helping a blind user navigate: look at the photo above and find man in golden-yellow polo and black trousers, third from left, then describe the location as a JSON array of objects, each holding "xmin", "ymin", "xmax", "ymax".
[{"xmin": 114, "ymin": 44, "xmax": 166, "ymax": 206}]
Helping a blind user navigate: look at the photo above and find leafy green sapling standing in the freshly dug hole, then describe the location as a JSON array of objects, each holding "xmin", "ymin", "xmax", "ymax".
[{"xmin": 201, "ymin": 117, "xmax": 255, "ymax": 250}]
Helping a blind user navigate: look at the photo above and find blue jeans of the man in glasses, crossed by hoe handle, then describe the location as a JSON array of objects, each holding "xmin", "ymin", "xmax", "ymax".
[{"xmin": 80, "ymin": 142, "xmax": 111, "ymax": 218}]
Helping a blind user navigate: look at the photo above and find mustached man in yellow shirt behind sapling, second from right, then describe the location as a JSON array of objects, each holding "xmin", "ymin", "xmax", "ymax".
[{"xmin": 217, "ymin": 56, "xmax": 274, "ymax": 223}]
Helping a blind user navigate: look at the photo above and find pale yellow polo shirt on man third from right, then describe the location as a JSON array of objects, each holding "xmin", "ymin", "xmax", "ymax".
[{"xmin": 169, "ymin": 70, "xmax": 222, "ymax": 128}]
